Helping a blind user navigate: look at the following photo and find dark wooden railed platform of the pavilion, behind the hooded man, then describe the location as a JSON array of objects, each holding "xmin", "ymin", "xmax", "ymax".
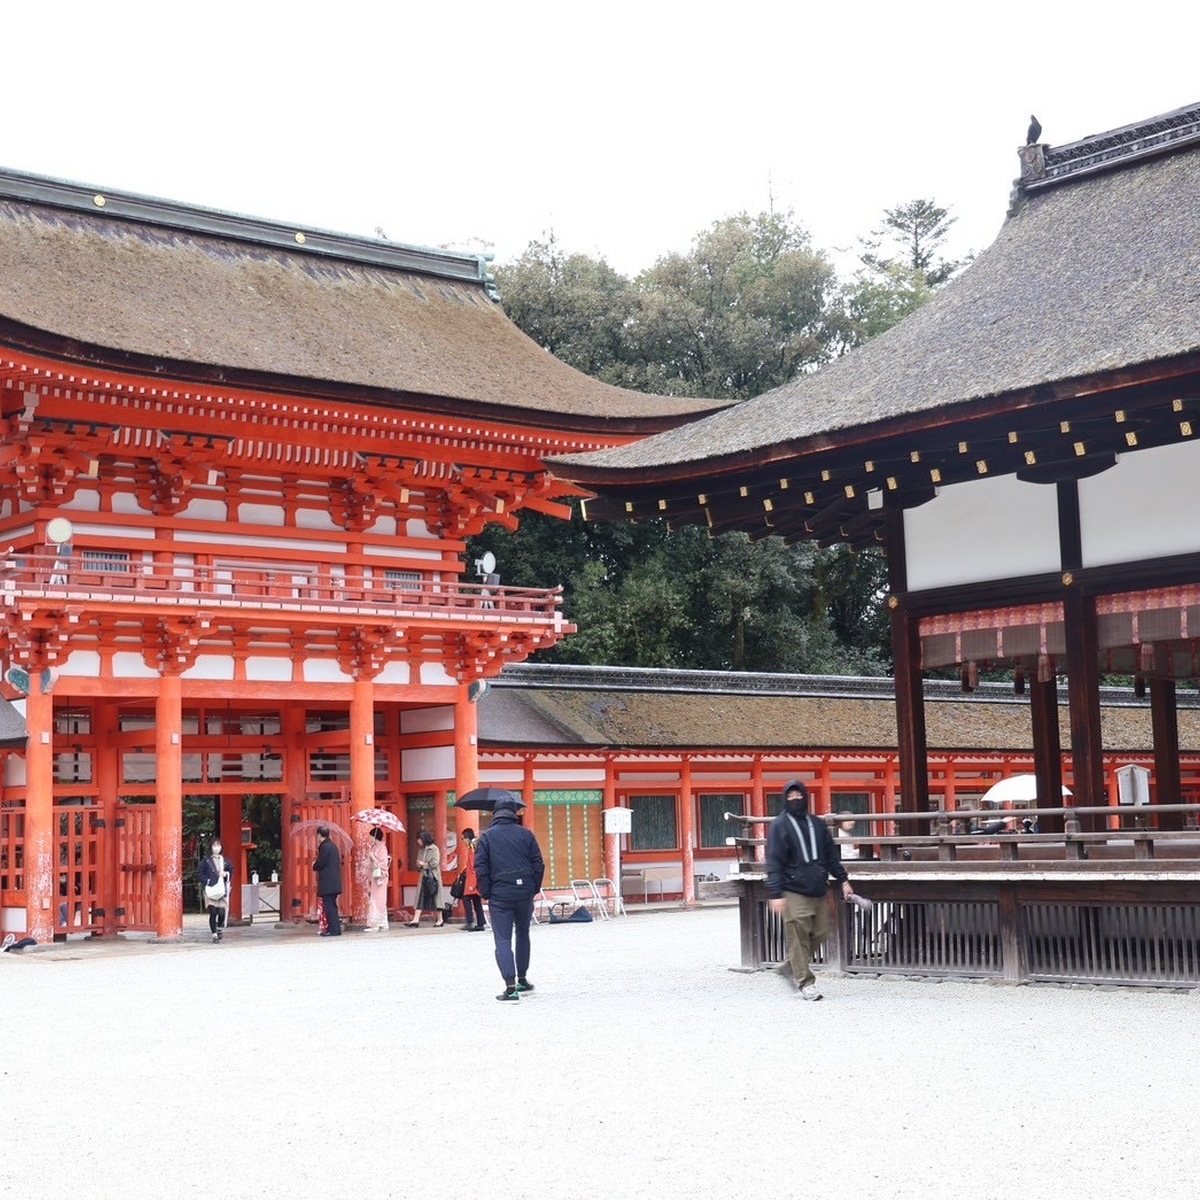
[{"xmin": 704, "ymin": 804, "xmax": 1200, "ymax": 988}]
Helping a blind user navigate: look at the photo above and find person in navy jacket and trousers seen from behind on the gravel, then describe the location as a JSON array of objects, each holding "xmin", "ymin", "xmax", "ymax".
[{"xmin": 475, "ymin": 796, "xmax": 546, "ymax": 1000}]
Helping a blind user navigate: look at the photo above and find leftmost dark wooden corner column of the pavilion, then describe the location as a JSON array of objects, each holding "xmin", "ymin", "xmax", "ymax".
[{"xmin": 887, "ymin": 510, "xmax": 929, "ymax": 812}]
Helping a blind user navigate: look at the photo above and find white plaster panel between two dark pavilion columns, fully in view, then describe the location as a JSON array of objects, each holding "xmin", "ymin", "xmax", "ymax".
[{"xmin": 904, "ymin": 475, "xmax": 1062, "ymax": 592}]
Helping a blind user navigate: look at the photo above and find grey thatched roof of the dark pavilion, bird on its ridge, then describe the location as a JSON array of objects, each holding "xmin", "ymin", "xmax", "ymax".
[{"xmin": 553, "ymin": 104, "xmax": 1200, "ymax": 486}]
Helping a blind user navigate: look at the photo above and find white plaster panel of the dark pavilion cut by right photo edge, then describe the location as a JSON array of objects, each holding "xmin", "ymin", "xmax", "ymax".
[{"xmin": 1079, "ymin": 442, "xmax": 1200, "ymax": 566}]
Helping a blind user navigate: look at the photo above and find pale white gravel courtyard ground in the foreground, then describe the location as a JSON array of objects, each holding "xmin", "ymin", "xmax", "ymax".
[{"xmin": 0, "ymin": 908, "xmax": 1200, "ymax": 1200}]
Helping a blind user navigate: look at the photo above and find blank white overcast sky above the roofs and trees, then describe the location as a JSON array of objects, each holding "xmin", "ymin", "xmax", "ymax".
[{"xmin": 9, "ymin": 0, "xmax": 1200, "ymax": 272}]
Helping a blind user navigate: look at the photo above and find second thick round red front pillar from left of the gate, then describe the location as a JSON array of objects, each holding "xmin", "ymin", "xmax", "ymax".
[{"xmin": 154, "ymin": 672, "xmax": 184, "ymax": 937}]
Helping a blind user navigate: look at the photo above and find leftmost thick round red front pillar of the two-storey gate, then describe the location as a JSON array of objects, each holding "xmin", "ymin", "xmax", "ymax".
[{"xmin": 25, "ymin": 666, "xmax": 58, "ymax": 942}]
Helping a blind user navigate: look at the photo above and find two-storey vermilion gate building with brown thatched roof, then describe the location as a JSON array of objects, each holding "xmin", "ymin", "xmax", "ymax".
[{"xmin": 0, "ymin": 172, "xmax": 719, "ymax": 941}]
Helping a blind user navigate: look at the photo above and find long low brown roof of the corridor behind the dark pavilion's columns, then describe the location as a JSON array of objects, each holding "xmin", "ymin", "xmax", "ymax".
[{"xmin": 479, "ymin": 664, "xmax": 1200, "ymax": 754}]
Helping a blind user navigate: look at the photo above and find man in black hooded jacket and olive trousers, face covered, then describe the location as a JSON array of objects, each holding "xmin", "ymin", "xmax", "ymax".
[{"xmin": 767, "ymin": 780, "xmax": 854, "ymax": 1000}]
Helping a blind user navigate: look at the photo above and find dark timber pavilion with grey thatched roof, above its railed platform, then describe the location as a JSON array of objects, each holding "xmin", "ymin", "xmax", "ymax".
[{"xmin": 552, "ymin": 104, "xmax": 1200, "ymax": 829}]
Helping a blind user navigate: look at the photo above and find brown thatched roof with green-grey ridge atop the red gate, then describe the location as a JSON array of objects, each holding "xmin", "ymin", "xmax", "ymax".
[{"xmin": 0, "ymin": 172, "xmax": 720, "ymax": 433}]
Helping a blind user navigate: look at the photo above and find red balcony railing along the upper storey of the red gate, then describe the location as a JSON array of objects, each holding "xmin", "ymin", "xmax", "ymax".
[{"xmin": 0, "ymin": 554, "xmax": 563, "ymax": 623}]
